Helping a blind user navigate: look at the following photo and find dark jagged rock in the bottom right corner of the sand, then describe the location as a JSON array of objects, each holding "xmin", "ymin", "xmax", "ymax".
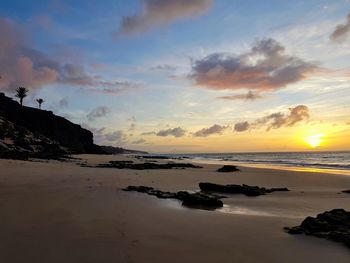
[{"xmin": 284, "ymin": 209, "xmax": 350, "ymax": 248}]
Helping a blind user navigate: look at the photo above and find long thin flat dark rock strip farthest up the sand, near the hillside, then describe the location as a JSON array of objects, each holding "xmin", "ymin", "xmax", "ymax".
[{"xmin": 97, "ymin": 161, "xmax": 202, "ymax": 170}]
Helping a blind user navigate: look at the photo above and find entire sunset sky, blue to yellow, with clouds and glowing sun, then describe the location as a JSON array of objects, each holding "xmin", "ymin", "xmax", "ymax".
[{"xmin": 0, "ymin": 0, "xmax": 350, "ymax": 153}]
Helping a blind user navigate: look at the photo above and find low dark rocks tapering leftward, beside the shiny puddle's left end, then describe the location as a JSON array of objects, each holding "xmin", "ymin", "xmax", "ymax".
[{"xmin": 123, "ymin": 186, "xmax": 223, "ymax": 210}]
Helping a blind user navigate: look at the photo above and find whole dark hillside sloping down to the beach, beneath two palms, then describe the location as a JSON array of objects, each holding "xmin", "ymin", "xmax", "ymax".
[{"xmin": 0, "ymin": 93, "xmax": 145, "ymax": 158}]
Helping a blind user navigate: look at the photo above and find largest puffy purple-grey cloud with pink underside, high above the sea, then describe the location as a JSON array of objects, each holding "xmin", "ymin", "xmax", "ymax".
[{"xmin": 189, "ymin": 38, "xmax": 317, "ymax": 92}]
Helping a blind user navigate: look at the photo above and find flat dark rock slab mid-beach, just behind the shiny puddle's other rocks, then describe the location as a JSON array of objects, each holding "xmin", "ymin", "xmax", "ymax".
[{"xmin": 199, "ymin": 183, "xmax": 289, "ymax": 196}]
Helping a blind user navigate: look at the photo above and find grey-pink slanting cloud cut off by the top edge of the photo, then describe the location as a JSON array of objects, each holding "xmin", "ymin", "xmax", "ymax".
[{"xmin": 118, "ymin": 0, "xmax": 213, "ymax": 36}]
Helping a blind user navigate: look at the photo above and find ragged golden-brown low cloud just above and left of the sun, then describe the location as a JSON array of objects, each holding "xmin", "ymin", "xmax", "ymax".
[{"xmin": 234, "ymin": 105, "xmax": 310, "ymax": 132}]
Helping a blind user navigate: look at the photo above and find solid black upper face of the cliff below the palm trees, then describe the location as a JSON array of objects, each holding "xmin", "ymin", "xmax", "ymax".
[{"xmin": 0, "ymin": 93, "xmax": 103, "ymax": 156}]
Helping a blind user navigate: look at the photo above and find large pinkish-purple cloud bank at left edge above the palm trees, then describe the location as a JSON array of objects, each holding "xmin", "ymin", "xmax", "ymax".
[{"xmin": 0, "ymin": 18, "xmax": 140, "ymax": 94}]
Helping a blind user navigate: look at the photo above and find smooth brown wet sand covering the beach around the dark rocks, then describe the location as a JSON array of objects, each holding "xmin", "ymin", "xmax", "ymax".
[{"xmin": 0, "ymin": 155, "xmax": 350, "ymax": 263}]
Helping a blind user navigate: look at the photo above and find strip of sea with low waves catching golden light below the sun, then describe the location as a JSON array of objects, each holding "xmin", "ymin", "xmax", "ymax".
[{"xmin": 148, "ymin": 151, "xmax": 350, "ymax": 173}]
